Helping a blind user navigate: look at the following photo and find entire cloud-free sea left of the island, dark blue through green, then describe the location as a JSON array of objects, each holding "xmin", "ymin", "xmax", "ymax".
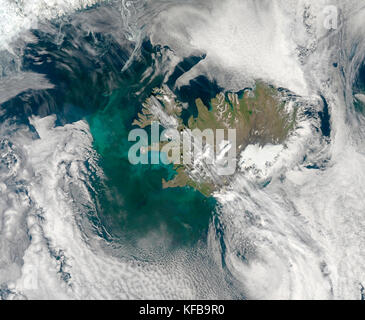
[{"xmin": 19, "ymin": 25, "xmax": 215, "ymax": 252}]
